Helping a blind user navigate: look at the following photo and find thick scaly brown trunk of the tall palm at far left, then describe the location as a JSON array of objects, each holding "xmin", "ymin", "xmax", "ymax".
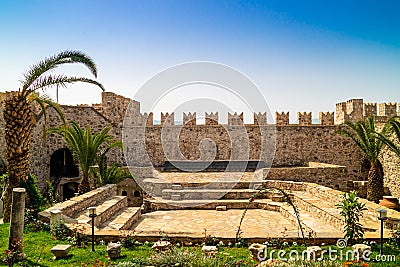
[{"xmin": 3, "ymin": 94, "xmax": 35, "ymax": 222}]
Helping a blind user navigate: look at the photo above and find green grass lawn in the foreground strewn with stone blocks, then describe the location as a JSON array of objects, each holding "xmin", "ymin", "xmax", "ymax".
[{"xmin": 0, "ymin": 224, "xmax": 400, "ymax": 267}]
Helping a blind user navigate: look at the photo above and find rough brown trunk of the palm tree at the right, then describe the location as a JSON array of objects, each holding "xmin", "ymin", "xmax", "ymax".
[{"xmin": 367, "ymin": 160, "xmax": 383, "ymax": 203}]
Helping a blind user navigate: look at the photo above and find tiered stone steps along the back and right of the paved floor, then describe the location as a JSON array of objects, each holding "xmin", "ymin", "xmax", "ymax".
[{"xmin": 145, "ymin": 180, "xmax": 400, "ymax": 238}]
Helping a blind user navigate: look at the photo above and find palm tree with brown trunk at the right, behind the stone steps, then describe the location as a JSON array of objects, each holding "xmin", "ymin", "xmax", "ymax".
[{"xmin": 335, "ymin": 117, "xmax": 390, "ymax": 202}]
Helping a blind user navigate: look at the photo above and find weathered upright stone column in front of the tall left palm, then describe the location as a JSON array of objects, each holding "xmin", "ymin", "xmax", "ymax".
[{"xmin": 8, "ymin": 188, "xmax": 25, "ymax": 252}]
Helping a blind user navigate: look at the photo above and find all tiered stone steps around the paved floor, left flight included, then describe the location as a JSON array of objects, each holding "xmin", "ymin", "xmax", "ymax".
[{"xmin": 39, "ymin": 179, "xmax": 400, "ymax": 241}]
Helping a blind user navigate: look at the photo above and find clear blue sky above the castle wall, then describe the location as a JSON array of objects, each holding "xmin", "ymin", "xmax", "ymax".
[{"xmin": 0, "ymin": 0, "xmax": 400, "ymax": 120}]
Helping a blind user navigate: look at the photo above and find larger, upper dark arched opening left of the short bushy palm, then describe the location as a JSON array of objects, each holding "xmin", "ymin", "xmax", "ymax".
[{"xmin": 50, "ymin": 148, "xmax": 79, "ymax": 178}]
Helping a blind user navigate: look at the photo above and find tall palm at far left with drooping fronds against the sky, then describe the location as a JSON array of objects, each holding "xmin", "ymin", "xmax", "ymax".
[{"xmin": 2, "ymin": 51, "xmax": 104, "ymax": 222}]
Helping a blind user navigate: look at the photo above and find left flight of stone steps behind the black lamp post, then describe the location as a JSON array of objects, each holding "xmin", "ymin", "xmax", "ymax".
[{"xmin": 39, "ymin": 184, "xmax": 141, "ymax": 232}]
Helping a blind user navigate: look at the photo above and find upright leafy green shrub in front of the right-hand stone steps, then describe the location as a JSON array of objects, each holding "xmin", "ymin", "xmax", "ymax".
[{"xmin": 336, "ymin": 191, "xmax": 367, "ymax": 242}]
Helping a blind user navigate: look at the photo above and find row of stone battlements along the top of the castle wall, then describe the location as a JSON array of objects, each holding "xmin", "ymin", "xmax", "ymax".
[{"xmin": 0, "ymin": 91, "xmax": 400, "ymax": 126}]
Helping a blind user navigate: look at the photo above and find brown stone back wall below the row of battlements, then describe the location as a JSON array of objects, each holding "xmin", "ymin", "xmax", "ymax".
[{"xmin": 126, "ymin": 125, "xmax": 367, "ymax": 190}]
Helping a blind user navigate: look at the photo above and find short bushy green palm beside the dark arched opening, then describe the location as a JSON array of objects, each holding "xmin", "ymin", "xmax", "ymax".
[{"xmin": 50, "ymin": 122, "xmax": 122, "ymax": 194}]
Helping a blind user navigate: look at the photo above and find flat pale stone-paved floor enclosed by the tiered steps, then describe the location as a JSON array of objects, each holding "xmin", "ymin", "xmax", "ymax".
[{"xmin": 133, "ymin": 209, "xmax": 304, "ymax": 238}]
